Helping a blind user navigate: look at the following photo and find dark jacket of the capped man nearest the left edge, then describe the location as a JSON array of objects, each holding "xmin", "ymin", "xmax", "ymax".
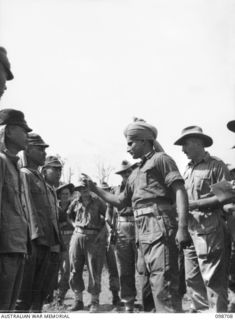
[{"xmin": 0, "ymin": 150, "xmax": 29, "ymax": 253}]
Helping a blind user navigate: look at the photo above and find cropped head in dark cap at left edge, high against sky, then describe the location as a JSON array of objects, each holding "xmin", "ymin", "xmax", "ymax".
[{"xmin": 0, "ymin": 47, "xmax": 14, "ymax": 99}]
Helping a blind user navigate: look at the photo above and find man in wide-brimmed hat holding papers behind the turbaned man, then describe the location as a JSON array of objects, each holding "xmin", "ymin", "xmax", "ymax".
[{"xmin": 175, "ymin": 126, "xmax": 230, "ymax": 312}]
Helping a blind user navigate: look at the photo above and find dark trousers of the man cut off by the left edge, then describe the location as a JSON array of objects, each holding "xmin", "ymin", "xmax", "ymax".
[{"xmin": 0, "ymin": 253, "xmax": 25, "ymax": 312}]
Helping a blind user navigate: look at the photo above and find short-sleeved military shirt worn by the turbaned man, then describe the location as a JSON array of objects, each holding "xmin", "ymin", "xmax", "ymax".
[{"xmin": 120, "ymin": 151, "xmax": 184, "ymax": 209}]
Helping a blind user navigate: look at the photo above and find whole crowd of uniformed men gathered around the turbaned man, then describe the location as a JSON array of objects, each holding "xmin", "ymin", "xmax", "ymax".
[{"xmin": 0, "ymin": 47, "xmax": 235, "ymax": 312}]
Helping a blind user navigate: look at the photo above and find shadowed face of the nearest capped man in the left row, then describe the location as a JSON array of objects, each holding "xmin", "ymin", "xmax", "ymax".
[{"xmin": 6, "ymin": 125, "xmax": 28, "ymax": 152}]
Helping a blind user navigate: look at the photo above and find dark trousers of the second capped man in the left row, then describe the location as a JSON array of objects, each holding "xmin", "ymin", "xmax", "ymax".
[{"xmin": 16, "ymin": 240, "xmax": 50, "ymax": 312}]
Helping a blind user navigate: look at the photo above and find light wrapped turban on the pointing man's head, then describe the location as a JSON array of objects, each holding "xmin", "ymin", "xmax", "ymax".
[{"xmin": 124, "ymin": 118, "xmax": 164, "ymax": 152}]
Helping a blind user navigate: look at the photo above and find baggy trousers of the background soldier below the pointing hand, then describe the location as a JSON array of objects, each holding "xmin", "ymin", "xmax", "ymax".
[{"xmin": 69, "ymin": 229, "xmax": 106, "ymax": 297}]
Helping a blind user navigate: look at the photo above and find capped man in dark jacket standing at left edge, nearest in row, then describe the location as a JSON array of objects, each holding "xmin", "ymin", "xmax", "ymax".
[{"xmin": 0, "ymin": 109, "xmax": 31, "ymax": 312}]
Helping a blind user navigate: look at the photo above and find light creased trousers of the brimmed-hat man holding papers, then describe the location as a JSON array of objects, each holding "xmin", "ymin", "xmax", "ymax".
[{"xmin": 184, "ymin": 221, "xmax": 228, "ymax": 312}]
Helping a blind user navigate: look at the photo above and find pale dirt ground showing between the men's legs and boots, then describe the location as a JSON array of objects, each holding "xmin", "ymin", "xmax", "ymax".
[{"xmin": 43, "ymin": 267, "xmax": 193, "ymax": 313}]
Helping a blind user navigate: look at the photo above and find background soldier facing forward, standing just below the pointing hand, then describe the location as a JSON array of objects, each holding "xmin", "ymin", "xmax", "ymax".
[{"xmin": 67, "ymin": 180, "xmax": 106, "ymax": 312}]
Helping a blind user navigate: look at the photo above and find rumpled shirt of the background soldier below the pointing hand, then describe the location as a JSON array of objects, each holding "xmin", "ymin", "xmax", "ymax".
[{"xmin": 67, "ymin": 192, "xmax": 106, "ymax": 230}]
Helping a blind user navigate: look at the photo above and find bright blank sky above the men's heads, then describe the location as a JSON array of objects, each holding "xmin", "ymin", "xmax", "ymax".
[{"xmin": 0, "ymin": 0, "xmax": 235, "ymax": 185}]
